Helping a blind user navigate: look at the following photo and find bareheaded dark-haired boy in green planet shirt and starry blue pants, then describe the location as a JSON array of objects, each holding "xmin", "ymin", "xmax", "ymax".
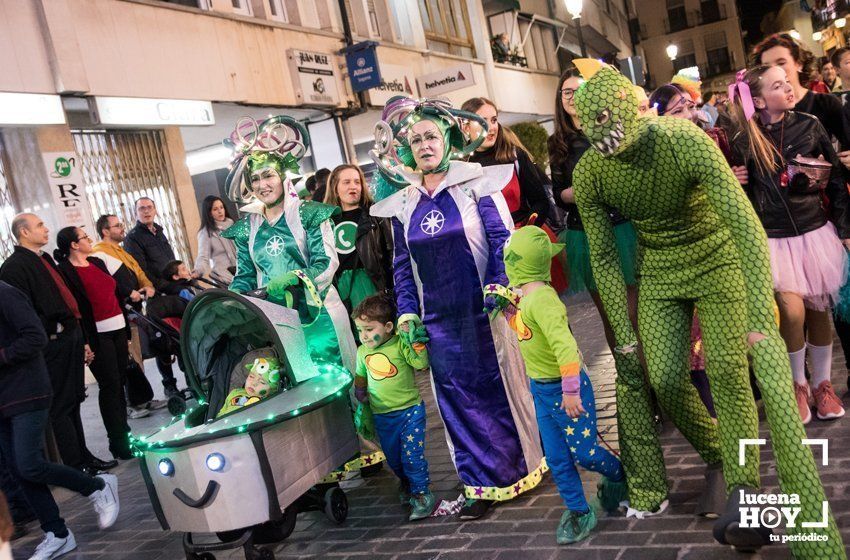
[{"xmin": 351, "ymin": 295, "xmax": 436, "ymax": 521}]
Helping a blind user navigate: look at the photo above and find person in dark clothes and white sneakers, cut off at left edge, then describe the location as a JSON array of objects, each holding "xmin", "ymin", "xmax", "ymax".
[{"xmin": 0, "ymin": 282, "xmax": 119, "ymax": 560}]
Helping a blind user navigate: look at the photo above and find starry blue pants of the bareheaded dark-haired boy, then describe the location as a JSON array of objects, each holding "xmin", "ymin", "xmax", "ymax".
[{"xmin": 374, "ymin": 403, "xmax": 431, "ymax": 494}]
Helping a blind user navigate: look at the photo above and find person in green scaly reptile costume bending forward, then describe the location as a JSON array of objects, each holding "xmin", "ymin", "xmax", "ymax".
[{"xmin": 574, "ymin": 59, "xmax": 846, "ymax": 560}]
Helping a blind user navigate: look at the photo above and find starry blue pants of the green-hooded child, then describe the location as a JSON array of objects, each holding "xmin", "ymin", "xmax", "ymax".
[{"xmin": 531, "ymin": 370, "xmax": 625, "ymax": 512}]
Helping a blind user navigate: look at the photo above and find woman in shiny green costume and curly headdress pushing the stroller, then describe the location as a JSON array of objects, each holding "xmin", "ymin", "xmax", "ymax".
[{"xmin": 224, "ymin": 116, "xmax": 356, "ymax": 372}]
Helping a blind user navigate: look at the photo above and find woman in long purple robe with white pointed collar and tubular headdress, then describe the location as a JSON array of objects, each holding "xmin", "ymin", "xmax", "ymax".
[{"xmin": 371, "ymin": 97, "xmax": 545, "ymax": 519}]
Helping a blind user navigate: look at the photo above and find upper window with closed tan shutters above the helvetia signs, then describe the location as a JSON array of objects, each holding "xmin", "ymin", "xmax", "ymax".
[{"xmin": 419, "ymin": 0, "xmax": 475, "ymax": 58}]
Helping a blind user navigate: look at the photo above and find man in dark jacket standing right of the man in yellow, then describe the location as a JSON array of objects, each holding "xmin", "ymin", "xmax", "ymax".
[{"xmin": 124, "ymin": 196, "xmax": 174, "ymax": 289}]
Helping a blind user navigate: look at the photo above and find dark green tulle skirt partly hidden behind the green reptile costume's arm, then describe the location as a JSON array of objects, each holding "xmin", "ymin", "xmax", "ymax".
[{"xmin": 559, "ymin": 222, "xmax": 637, "ymax": 294}]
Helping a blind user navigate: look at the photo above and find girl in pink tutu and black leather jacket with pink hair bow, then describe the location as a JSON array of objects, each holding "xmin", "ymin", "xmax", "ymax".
[{"xmin": 730, "ymin": 66, "xmax": 850, "ymax": 424}]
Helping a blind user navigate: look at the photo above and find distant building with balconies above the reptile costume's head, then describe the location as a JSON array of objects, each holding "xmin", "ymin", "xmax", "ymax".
[{"xmin": 630, "ymin": 0, "xmax": 747, "ymax": 90}]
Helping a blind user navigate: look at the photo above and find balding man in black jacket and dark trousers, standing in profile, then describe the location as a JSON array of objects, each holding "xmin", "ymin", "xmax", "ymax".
[{"xmin": 0, "ymin": 214, "xmax": 118, "ymax": 471}]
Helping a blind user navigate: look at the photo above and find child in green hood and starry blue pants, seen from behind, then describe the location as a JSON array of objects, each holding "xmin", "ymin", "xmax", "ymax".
[{"xmin": 504, "ymin": 226, "xmax": 626, "ymax": 544}]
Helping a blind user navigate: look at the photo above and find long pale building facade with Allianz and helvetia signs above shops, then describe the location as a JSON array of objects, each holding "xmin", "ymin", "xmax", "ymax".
[{"xmin": 0, "ymin": 0, "xmax": 632, "ymax": 260}]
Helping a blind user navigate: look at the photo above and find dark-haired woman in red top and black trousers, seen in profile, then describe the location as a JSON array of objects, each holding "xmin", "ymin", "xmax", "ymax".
[{"xmin": 54, "ymin": 226, "xmax": 132, "ymax": 460}]
